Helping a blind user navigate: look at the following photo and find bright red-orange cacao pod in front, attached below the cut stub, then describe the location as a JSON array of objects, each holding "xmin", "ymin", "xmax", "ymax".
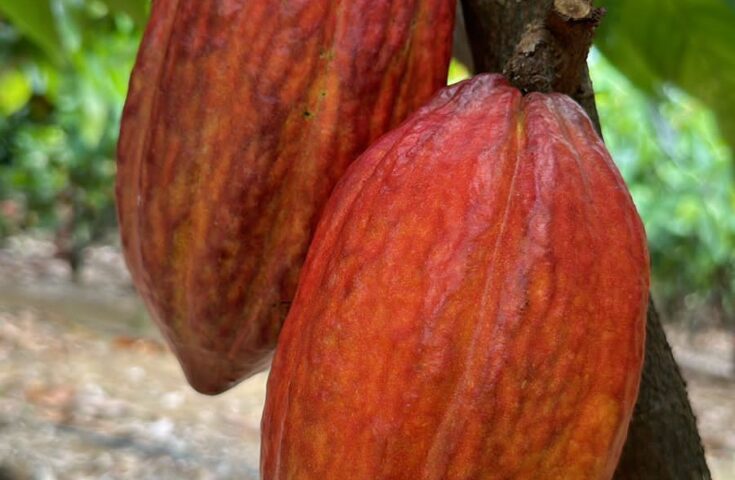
[{"xmin": 261, "ymin": 75, "xmax": 649, "ymax": 480}]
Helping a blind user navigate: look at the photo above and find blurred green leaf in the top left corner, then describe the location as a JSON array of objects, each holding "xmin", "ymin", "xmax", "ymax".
[{"xmin": 0, "ymin": 0, "xmax": 64, "ymax": 61}]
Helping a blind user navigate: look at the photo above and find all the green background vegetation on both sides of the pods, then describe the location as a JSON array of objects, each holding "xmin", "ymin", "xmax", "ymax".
[{"xmin": 0, "ymin": 0, "xmax": 735, "ymax": 326}]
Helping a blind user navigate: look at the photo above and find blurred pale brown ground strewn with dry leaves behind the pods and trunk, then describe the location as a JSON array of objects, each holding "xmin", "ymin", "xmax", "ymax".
[{"xmin": 0, "ymin": 238, "xmax": 735, "ymax": 480}]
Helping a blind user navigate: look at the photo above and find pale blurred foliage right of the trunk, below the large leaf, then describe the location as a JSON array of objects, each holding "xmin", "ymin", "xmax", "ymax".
[{"xmin": 589, "ymin": 50, "xmax": 735, "ymax": 324}]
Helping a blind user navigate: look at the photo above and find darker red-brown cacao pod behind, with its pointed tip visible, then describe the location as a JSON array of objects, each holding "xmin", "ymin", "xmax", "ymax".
[{"xmin": 117, "ymin": 0, "xmax": 455, "ymax": 394}]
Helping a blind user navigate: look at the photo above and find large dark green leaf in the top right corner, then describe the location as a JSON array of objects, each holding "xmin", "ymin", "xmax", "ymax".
[{"xmin": 597, "ymin": 0, "xmax": 735, "ymax": 146}]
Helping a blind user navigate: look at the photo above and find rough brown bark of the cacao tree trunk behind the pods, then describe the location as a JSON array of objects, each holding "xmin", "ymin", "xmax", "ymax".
[{"xmin": 460, "ymin": 0, "xmax": 711, "ymax": 480}]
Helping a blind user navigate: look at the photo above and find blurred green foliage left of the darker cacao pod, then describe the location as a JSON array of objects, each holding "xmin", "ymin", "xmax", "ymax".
[{"xmin": 0, "ymin": 0, "xmax": 140, "ymax": 267}]
